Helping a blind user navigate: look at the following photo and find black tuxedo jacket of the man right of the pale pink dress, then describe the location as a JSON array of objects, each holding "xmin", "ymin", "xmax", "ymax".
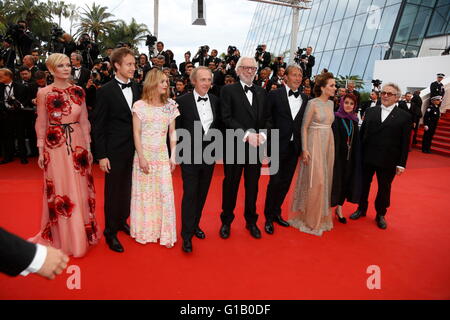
[{"xmin": 175, "ymin": 92, "xmax": 221, "ymax": 164}]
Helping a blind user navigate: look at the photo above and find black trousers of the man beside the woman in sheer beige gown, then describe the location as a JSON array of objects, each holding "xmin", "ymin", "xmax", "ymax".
[{"xmin": 264, "ymin": 141, "xmax": 298, "ymax": 222}]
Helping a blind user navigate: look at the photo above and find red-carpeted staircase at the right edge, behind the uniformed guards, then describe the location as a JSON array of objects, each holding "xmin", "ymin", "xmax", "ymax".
[{"xmin": 415, "ymin": 110, "xmax": 450, "ymax": 157}]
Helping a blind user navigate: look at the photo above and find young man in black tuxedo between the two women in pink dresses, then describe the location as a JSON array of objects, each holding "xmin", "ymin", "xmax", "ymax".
[{"xmin": 92, "ymin": 47, "xmax": 140, "ymax": 252}]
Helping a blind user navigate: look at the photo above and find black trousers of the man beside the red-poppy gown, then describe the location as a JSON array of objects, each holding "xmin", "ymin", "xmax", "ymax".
[{"xmin": 104, "ymin": 153, "xmax": 134, "ymax": 236}]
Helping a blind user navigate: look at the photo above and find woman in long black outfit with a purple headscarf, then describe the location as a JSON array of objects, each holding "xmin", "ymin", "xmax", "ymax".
[{"xmin": 331, "ymin": 93, "xmax": 361, "ymax": 223}]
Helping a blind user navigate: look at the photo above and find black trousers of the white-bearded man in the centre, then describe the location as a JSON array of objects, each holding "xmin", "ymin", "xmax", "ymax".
[{"xmin": 220, "ymin": 164, "xmax": 261, "ymax": 225}]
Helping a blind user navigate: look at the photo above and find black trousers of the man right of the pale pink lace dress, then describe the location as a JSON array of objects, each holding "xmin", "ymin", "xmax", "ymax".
[{"xmin": 181, "ymin": 164, "xmax": 214, "ymax": 240}]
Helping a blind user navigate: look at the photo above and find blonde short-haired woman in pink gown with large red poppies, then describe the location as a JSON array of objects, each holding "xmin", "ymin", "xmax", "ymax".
[{"xmin": 30, "ymin": 53, "xmax": 99, "ymax": 257}]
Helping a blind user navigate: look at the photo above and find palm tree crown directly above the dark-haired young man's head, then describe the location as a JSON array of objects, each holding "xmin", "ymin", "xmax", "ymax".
[{"xmin": 101, "ymin": 18, "xmax": 150, "ymax": 47}]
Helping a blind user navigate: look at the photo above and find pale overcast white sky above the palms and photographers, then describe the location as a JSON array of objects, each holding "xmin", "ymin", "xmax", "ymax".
[{"xmin": 61, "ymin": 0, "xmax": 257, "ymax": 64}]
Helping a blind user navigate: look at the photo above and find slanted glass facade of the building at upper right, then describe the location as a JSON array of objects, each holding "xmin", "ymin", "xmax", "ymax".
[{"xmin": 242, "ymin": 0, "xmax": 450, "ymax": 89}]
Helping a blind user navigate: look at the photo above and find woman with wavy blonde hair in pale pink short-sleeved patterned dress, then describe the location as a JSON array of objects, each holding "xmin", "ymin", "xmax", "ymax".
[{"xmin": 130, "ymin": 69, "xmax": 180, "ymax": 248}]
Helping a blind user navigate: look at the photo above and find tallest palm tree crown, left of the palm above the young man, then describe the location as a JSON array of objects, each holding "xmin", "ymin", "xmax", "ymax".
[{"xmin": 77, "ymin": 2, "xmax": 116, "ymax": 42}]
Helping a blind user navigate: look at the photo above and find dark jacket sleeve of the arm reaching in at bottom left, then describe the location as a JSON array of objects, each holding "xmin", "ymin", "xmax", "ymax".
[{"xmin": 0, "ymin": 228, "xmax": 37, "ymax": 276}]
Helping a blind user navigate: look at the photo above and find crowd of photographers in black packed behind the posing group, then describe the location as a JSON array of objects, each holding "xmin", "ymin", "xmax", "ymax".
[{"xmin": 0, "ymin": 21, "xmax": 436, "ymax": 164}]
